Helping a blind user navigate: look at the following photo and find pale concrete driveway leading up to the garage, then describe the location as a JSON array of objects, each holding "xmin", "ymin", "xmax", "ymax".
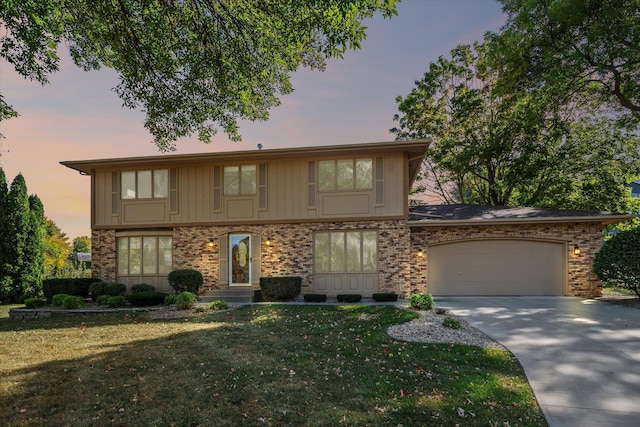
[{"xmin": 435, "ymin": 297, "xmax": 640, "ymax": 427}]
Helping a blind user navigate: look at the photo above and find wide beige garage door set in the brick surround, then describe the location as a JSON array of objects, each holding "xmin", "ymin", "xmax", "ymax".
[{"xmin": 427, "ymin": 240, "xmax": 566, "ymax": 296}]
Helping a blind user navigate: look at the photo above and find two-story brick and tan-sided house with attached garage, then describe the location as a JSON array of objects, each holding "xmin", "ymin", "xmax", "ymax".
[{"xmin": 62, "ymin": 141, "xmax": 630, "ymax": 297}]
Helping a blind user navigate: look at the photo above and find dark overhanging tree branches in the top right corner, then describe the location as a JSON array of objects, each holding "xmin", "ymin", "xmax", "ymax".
[{"xmin": 491, "ymin": 0, "xmax": 640, "ymax": 123}]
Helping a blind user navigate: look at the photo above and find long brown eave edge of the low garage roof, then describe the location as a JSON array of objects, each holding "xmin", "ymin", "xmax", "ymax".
[{"xmin": 407, "ymin": 214, "xmax": 636, "ymax": 227}]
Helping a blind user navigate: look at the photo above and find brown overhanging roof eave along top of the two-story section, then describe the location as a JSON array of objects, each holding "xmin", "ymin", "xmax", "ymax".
[{"xmin": 60, "ymin": 139, "xmax": 431, "ymax": 176}]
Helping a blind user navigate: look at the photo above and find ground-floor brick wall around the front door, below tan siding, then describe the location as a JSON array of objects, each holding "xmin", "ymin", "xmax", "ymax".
[{"xmin": 92, "ymin": 221, "xmax": 411, "ymax": 295}]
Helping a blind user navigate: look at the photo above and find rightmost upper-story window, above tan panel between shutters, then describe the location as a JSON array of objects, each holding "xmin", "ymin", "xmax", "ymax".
[{"xmin": 318, "ymin": 158, "xmax": 373, "ymax": 191}]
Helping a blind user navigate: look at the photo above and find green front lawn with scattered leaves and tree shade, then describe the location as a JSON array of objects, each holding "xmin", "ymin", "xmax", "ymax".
[{"xmin": 0, "ymin": 305, "xmax": 546, "ymax": 427}]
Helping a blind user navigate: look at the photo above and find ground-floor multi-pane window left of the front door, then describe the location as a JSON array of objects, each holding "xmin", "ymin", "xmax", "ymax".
[{"xmin": 118, "ymin": 236, "xmax": 173, "ymax": 276}]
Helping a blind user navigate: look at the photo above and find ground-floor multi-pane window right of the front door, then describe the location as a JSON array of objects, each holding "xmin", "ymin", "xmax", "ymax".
[{"xmin": 314, "ymin": 230, "xmax": 378, "ymax": 273}]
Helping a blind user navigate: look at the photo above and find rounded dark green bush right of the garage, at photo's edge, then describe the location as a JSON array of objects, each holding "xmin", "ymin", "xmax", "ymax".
[{"xmin": 593, "ymin": 227, "xmax": 640, "ymax": 298}]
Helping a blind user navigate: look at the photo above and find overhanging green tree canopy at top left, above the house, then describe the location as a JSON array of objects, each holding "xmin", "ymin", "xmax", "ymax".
[{"xmin": 0, "ymin": 0, "xmax": 396, "ymax": 150}]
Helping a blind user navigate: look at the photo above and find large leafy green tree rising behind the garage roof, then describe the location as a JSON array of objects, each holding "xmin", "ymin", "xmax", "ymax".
[{"xmin": 392, "ymin": 44, "xmax": 640, "ymax": 210}]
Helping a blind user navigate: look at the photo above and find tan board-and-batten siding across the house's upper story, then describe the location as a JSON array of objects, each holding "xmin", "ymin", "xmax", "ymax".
[{"xmin": 92, "ymin": 153, "xmax": 407, "ymax": 228}]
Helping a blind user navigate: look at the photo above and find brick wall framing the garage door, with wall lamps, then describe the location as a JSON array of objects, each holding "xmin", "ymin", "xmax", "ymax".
[{"xmin": 411, "ymin": 223, "xmax": 602, "ymax": 297}]
